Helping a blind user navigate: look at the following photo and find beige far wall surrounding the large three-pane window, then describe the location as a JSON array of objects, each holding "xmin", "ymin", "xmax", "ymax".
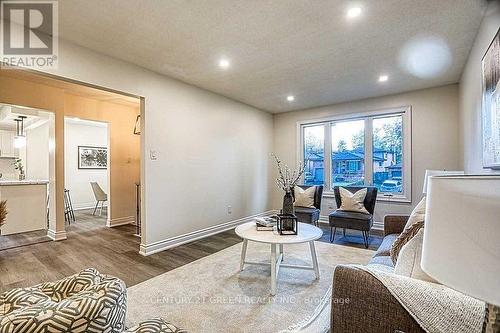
[{"xmin": 274, "ymin": 84, "xmax": 460, "ymax": 222}]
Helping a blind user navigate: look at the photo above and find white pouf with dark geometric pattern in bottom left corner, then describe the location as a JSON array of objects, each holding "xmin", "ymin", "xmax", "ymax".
[{"xmin": 0, "ymin": 269, "xmax": 127, "ymax": 333}]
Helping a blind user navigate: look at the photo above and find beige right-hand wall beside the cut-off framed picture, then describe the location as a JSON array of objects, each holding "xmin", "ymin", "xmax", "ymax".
[{"xmin": 459, "ymin": 1, "xmax": 500, "ymax": 173}]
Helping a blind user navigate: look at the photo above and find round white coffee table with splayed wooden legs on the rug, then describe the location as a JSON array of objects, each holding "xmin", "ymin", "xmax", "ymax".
[{"xmin": 235, "ymin": 222, "xmax": 323, "ymax": 296}]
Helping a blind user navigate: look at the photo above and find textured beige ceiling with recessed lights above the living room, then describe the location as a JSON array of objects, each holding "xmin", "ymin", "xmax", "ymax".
[{"xmin": 59, "ymin": 0, "xmax": 487, "ymax": 112}]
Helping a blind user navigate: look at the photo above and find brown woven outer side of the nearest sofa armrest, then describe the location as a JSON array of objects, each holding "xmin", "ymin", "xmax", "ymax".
[{"xmin": 330, "ymin": 265, "xmax": 424, "ymax": 333}]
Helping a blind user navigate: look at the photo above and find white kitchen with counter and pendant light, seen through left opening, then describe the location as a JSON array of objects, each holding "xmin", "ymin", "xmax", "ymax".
[{"xmin": 0, "ymin": 104, "xmax": 53, "ymax": 236}]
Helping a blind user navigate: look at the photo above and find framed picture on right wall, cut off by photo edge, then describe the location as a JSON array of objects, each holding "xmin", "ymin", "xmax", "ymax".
[{"xmin": 481, "ymin": 29, "xmax": 500, "ymax": 169}]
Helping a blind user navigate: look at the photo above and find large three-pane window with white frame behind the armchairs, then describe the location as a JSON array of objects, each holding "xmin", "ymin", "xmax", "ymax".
[{"xmin": 299, "ymin": 108, "xmax": 411, "ymax": 201}]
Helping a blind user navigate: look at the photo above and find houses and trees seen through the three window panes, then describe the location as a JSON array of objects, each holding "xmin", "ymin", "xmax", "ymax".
[{"xmin": 304, "ymin": 115, "xmax": 403, "ymax": 194}]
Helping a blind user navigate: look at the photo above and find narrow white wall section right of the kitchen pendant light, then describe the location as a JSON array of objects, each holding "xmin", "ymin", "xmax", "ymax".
[{"xmin": 25, "ymin": 121, "xmax": 50, "ymax": 180}]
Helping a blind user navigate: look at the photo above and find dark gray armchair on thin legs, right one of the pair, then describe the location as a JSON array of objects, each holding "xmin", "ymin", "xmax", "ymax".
[{"xmin": 328, "ymin": 186, "xmax": 377, "ymax": 248}]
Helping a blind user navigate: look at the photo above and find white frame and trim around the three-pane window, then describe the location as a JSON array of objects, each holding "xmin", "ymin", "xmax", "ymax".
[{"xmin": 296, "ymin": 105, "xmax": 413, "ymax": 203}]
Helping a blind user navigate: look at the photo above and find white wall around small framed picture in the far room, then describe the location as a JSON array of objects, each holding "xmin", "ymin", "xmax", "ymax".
[{"xmin": 64, "ymin": 120, "xmax": 109, "ymax": 209}]
